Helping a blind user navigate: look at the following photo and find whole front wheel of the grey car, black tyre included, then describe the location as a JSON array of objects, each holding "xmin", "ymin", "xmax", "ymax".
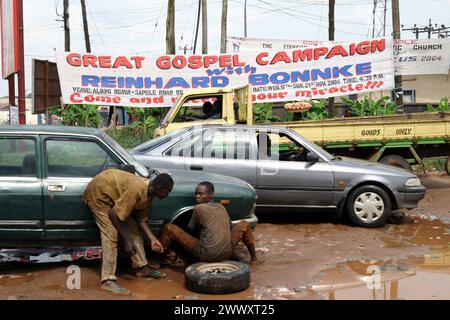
[{"xmin": 347, "ymin": 185, "xmax": 392, "ymax": 228}]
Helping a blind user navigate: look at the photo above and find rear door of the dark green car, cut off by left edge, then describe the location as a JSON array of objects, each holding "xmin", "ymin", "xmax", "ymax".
[{"xmin": 0, "ymin": 135, "xmax": 44, "ymax": 244}]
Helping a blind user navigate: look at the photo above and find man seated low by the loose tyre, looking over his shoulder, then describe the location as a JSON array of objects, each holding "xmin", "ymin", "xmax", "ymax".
[{"xmin": 160, "ymin": 181, "xmax": 264, "ymax": 264}]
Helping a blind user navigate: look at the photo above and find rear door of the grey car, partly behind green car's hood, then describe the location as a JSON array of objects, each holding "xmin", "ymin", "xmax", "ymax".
[{"xmin": 179, "ymin": 127, "xmax": 256, "ymax": 186}]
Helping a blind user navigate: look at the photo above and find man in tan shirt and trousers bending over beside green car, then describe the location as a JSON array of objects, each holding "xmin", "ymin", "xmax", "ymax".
[{"xmin": 83, "ymin": 169, "xmax": 173, "ymax": 295}]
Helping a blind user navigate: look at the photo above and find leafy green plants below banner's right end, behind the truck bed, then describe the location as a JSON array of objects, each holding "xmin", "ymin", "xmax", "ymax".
[{"xmin": 342, "ymin": 96, "xmax": 397, "ymax": 117}]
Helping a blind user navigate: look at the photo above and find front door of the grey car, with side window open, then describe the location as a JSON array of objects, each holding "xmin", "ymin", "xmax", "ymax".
[{"xmin": 254, "ymin": 129, "xmax": 336, "ymax": 209}]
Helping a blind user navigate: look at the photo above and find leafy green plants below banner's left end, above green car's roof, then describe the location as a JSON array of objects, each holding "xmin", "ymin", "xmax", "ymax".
[{"xmin": 49, "ymin": 104, "xmax": 102, "ymax": 128}]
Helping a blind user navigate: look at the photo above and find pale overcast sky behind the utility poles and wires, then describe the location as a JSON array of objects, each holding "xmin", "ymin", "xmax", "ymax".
[{"xmin": 0, "ymin": 0, "xmax": 450, "ymax": 96}]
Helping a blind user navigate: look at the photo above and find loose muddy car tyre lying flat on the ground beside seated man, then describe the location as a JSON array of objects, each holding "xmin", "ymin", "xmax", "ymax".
[{"xmin": 185, "ymin": 261, "xmax": 250, "ymax": 294}]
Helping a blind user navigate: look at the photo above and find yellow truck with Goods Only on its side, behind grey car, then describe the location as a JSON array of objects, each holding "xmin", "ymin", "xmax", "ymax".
[{"xmin": 155, "ymin": 85, "xmax": 450, "ymax": 175}]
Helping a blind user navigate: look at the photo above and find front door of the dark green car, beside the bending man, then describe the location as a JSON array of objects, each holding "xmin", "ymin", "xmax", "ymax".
[{"xmin": 43, "ymin": 136, "xmax": 120, "ymax": 243}]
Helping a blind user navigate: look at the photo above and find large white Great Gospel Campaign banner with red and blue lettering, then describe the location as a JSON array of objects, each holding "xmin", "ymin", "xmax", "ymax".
[{"xmin": 56, "ymin": 38, "xmax": 394, "ymax": 107}]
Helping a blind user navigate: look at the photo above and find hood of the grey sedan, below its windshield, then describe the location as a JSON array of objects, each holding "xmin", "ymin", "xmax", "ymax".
[{"xmin": 330, "ymin": 157, "xmax": 416, "ymax": 177}]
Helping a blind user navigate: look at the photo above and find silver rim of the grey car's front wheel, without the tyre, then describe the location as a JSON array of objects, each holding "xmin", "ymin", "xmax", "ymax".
[{"xmin": 353, "ymin": 192, "xmax": 384, "ymax": 223}]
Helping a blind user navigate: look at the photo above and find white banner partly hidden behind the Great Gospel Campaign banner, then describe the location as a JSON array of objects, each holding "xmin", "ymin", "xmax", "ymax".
[{"xmin": 227, "ymin": 37, "xmax": 450, "ymax": 75}]
